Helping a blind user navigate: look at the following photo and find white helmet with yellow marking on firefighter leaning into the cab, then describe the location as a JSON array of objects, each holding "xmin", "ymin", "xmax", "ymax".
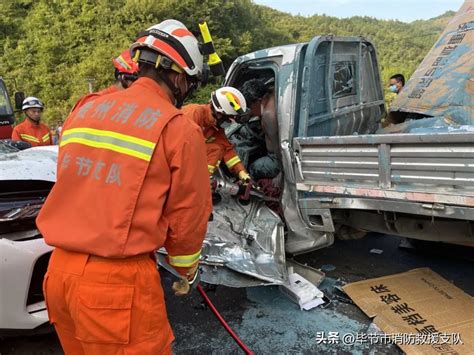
[{"xmin": 211, "ymin": 86, "xmax": 247, "ymax": 116}]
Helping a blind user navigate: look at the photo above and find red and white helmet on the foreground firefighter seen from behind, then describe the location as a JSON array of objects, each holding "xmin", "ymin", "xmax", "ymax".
[{"xmin": 130, "ymin": 20, "xmax": 203, "ymax": 79}]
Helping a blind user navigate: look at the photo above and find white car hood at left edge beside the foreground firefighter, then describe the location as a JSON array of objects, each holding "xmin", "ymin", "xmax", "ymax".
[{"xmin": 0, "ymin": 146, "xmax": 58, "ymax": 182}]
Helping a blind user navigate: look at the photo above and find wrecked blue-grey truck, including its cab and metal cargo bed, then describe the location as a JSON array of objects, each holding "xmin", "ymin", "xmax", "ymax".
[{"xmin": 220, "ymin": 18, "xmax": 474, "ymax": 254}]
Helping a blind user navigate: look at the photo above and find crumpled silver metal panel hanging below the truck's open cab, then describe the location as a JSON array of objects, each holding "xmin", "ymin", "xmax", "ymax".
[{"xmin": 201, "ymin": 177, "xmax": 287, "ymax": 287}]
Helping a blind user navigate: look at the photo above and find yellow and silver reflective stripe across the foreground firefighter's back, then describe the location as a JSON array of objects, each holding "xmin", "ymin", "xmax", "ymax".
[{"xmin": 60, "ymin": 128, "xmax": 156, "ymax": 161}]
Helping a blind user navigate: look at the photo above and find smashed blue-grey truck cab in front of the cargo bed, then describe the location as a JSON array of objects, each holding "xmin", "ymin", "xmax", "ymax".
[{"xmin": 226, "ymin": 36, "xmax": 385, "ymax": 254}]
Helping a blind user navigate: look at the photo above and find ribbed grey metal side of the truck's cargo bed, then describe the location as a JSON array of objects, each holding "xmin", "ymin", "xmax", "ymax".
[{"xmin": 294, "ymin": 132, "xmax": 474, "ymax": 216}]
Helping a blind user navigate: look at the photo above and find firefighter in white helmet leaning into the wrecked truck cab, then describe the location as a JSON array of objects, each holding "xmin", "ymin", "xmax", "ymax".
[{"xmin": 183, "ymin": 86, "xmax": 250, "ymax": 182}]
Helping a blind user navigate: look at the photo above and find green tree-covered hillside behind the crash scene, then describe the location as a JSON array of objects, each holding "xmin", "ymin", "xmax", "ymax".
[{"xmin": 0, "ymin": 0, "xmax": 452, "ymax": 125}]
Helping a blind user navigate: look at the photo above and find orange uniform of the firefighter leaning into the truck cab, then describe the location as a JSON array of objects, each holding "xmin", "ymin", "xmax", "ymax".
[{"xmin": 183, "ymin": 104, "xmax": 245, "ymax": 175}]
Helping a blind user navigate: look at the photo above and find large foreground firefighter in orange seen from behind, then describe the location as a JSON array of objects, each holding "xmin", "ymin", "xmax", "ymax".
[{"xmin": 37, "ymin": 20, "xmax": 211, "ymax": 355}]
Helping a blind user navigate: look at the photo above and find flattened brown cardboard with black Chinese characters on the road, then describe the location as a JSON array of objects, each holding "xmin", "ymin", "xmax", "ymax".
[{"xmin": 343, "ymin": 268, "xmax": 474, "ymax": 355}]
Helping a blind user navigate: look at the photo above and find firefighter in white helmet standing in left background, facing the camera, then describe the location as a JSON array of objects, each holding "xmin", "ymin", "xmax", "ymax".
[{"xmin": 12, "ymin": 96, "xmax": 53, "ymax": 147}]
